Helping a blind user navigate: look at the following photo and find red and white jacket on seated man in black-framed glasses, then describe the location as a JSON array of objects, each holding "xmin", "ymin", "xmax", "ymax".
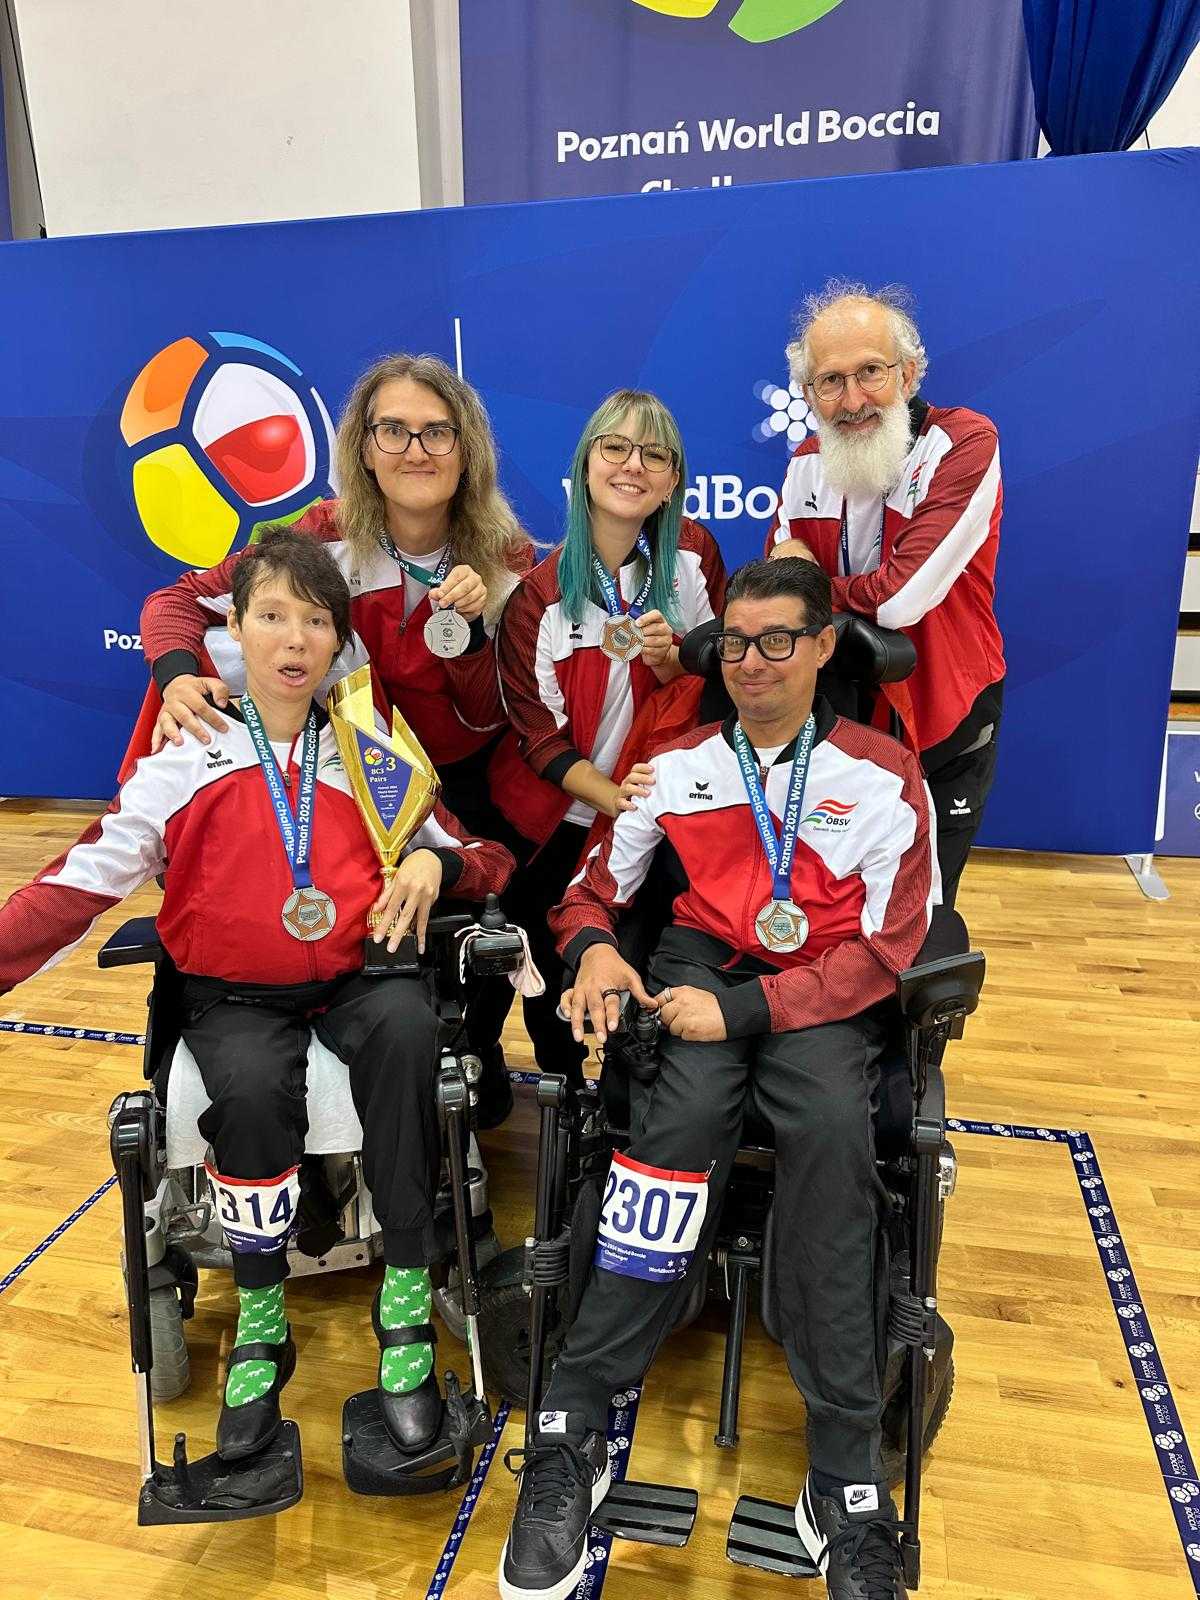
[{"xmin": 550, "ymin": 699, "xmax": 939, "ymax": 1038}]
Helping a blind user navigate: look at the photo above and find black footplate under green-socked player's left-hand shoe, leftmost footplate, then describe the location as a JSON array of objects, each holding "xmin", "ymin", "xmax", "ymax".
[{"xmin": 138, "ymin": 1421, "xmax": 304, "ymax": 1528}]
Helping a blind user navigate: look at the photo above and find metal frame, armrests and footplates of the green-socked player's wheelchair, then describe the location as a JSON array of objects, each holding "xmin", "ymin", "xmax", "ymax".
[{"xmin": 98, "ymin": 896, "xmax": 523, "ymax": 1525}]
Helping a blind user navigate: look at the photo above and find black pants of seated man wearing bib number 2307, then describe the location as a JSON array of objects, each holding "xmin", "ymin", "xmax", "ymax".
[{"xmin": 542, "ymin": 930, "xmax": 886, "ymax": 1482}]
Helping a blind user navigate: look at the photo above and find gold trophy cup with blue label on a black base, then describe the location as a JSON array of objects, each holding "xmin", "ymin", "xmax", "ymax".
[{"xmin": 326, "ymin": 667, "xmax": 442, "ymax": 976}]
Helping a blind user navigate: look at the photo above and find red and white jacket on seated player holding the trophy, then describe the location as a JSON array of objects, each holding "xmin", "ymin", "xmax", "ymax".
[{"xmin": 0, "ymin": 706, "xmax": 514, "ymax": 994}]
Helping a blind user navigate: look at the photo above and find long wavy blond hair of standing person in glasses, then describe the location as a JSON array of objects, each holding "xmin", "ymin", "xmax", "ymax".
[{"xmin": 338, "ymin": 355, "xmax": 533, "ymax": 621}]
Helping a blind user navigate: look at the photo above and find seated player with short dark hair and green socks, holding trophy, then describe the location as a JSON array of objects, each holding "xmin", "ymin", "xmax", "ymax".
[{"xmin": 0, "ymin": 530, "xmax": 512, "ymax": 1461}]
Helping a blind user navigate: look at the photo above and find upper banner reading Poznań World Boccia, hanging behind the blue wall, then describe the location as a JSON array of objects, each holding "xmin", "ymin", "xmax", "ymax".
[{"xmin": 459, "ymin": 0, "xmax": 1037, "ymax": 202}]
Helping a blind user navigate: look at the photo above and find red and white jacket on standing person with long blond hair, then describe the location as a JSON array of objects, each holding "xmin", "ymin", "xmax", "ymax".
[{"xmin": 141, "ymin": 501, "xmax": 533, "ymax": 768}]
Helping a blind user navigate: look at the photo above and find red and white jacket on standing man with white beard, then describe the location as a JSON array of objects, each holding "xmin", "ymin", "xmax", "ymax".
[{"xmin": 763, "ymin": 398, "xmax": 1005, "ymax": 750}]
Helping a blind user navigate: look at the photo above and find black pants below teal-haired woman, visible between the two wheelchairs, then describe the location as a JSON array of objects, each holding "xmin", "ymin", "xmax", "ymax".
[{"xmin": 467, "ymin": 822, "xmax": 587, "ymax": 1085}]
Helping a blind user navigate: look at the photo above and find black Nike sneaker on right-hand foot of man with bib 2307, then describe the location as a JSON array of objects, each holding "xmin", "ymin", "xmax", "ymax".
[{"xmin": 795, "ymin": 1474, "xmax": 909, "ymax": 1600}]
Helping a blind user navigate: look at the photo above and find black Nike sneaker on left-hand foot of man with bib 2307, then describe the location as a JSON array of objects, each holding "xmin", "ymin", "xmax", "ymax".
[{"xmin": 499, "ymin": 1413, "xmax": 611, "ymax": 1600}]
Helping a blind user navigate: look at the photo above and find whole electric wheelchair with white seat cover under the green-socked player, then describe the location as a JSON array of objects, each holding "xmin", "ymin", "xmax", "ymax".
[{"xmin": 98, "ymin": 894, "xmax": 523, "ymax": 1523}]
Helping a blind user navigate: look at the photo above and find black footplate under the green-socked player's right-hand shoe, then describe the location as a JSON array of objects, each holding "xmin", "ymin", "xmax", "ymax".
[{"xmin": 342, "ymin": 1373, "xmax": 491, "ymax": 1494}]
